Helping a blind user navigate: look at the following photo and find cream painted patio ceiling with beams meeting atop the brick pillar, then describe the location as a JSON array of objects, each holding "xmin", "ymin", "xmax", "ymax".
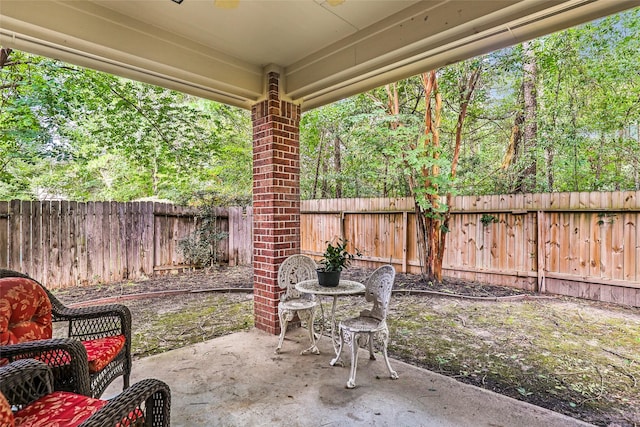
[{"xmin": 0, "ymin": 0, "xmax": 640, "ymax": 109}]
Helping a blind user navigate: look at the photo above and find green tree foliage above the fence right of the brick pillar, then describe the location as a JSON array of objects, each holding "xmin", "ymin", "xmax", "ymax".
[{"xmin": 301, "ymin": 8, "xmax": 640, "ymax": 200}]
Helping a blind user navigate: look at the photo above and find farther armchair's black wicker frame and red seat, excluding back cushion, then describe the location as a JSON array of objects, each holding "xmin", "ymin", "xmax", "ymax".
[{"xmin": 0, "ymin": 269, "xmax": 131, "ymax": 397}]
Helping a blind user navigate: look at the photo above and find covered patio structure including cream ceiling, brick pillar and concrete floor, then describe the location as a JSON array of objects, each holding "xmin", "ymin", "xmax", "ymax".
[{"xmin": 0, "ymin": 0, "xmax": 640, "ymax": 426}]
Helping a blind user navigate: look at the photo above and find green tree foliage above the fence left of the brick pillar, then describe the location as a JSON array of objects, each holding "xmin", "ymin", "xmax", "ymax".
[{"xmin": 0, "ymin": 51, "xmax": 251, "ymax": 201}]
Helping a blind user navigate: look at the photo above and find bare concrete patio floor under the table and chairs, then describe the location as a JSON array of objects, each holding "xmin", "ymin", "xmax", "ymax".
[{"xmin": 103, "ymin": 328, "xmax": 589, "ymax": 427}]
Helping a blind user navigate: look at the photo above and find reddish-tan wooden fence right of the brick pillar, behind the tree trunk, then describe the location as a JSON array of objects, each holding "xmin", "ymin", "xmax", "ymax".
[{"xmin": 301, "ymin": 192, "xmax": 640, "ymax": 306}]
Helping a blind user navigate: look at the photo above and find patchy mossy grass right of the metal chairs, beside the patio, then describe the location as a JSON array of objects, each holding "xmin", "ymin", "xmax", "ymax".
[{"xmin": 389, "ymin": 296, "xmax": 640, "ymax": 426}]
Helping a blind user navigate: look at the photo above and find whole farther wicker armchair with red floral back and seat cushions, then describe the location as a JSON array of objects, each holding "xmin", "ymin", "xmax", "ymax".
[{"xmin": 0, "ymin": 269, "xmax": 131, "ymax": 398}]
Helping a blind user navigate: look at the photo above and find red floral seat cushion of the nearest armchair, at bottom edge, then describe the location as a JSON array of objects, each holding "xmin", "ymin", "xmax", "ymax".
[{"xmin": 12, "ymin": 391, "xmax": 143, "ymax": 427}]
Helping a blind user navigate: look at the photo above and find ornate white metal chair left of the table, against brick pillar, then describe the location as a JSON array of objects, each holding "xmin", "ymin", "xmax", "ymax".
[{"xmin": 276, "ymin": 255, "xmax": 320, "ymax": 354}]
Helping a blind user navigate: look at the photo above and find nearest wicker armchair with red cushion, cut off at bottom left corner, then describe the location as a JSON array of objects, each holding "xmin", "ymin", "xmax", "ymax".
[{"xmin": 0, "ymin": 359, "xmax": 171, "ymax": 427}]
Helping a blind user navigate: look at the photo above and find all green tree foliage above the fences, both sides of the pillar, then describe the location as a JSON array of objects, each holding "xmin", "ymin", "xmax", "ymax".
[{"xmin": 0, "ymin": 8, "xmax": 640, "ymax": 202}]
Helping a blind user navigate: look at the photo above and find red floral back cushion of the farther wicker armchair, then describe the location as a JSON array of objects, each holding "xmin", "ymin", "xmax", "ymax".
[{"xmin": 0, "ymin": 277, "xmax": 53, "ymax": 345}]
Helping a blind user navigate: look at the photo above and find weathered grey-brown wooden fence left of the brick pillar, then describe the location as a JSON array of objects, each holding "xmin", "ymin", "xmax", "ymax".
[{"xmin": 0, "ymin": 200, "xmax": 252, "ymax": 289}]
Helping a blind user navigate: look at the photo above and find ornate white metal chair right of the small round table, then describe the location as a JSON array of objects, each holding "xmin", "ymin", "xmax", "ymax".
[{"xmin": 331, "ymin": 265, "xmax": 398, "ymax": 388}]
